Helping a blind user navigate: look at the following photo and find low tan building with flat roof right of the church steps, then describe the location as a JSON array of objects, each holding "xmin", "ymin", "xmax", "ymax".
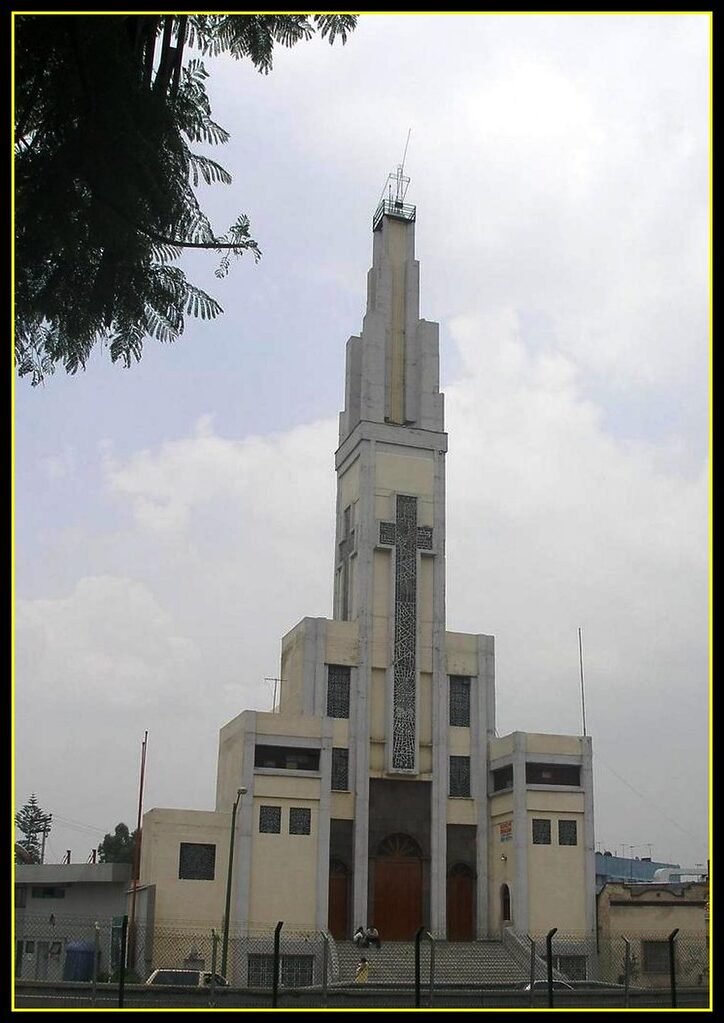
[{"xmin": 597, "ymin": 882, "xmax": 709, "ymax": 987}]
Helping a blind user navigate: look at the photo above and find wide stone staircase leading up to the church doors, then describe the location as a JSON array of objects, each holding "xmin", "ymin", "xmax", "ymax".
[{"xmin": 334, "ymin": 941, "xmax": 528, "ymax": 986}]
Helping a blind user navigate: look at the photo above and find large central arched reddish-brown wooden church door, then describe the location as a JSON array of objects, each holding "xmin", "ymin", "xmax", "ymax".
[{"xmin": 369, "ymin": 835, "xmax": 422, "ymax": 941}]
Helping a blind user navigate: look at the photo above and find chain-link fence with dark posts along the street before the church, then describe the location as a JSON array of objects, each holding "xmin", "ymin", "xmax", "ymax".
[{"xmin": 14, "ymin": 915, "xmax": 709, "ymax": 1009}]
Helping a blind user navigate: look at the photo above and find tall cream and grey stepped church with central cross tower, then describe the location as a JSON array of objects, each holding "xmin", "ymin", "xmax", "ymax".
[{"xmin": 140, "ymin": 188, "xmax": 595, "ymax": 977}]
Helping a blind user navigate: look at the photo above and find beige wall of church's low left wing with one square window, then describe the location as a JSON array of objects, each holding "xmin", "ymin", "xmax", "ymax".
[{"xmin": 140, "ymin": 808, "xmax": 231, "ymax": 937}]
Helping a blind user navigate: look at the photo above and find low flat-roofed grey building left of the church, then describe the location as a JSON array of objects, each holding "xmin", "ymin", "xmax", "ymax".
[{"xmin": 15, "ymin": 863, "xmax": 131, "ymax": 980}]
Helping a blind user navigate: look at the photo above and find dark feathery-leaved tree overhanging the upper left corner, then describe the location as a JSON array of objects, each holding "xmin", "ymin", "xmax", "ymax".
[{"xmin": 13, "ymin": 14, "xmax": 357, "ymax": 384}]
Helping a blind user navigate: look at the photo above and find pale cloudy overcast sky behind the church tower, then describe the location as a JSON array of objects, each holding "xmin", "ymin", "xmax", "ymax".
[{"xmin": 15, "ymin": 14, "xmax": 710, "ymax": 864}]
